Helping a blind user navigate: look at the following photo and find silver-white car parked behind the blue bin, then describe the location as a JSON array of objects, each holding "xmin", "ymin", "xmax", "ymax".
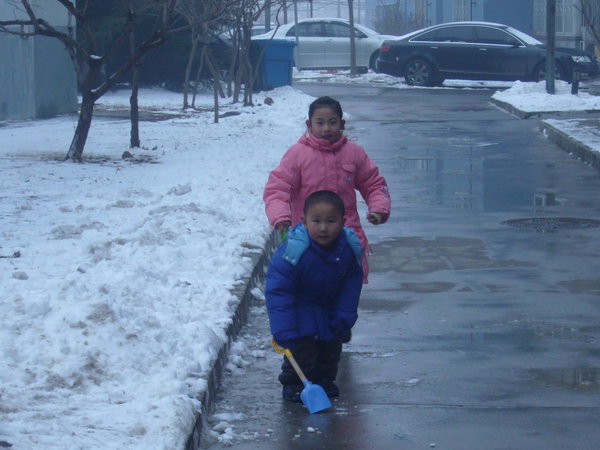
[{"xmin": 252, "ymin": 18, "xmax": 396, "ymax": 69}]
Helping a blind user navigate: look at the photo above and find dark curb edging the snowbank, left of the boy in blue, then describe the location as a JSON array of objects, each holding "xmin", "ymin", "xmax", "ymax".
[{"xmin": 185, "ymin": 232, "xmax": 278, "ymax": 450}]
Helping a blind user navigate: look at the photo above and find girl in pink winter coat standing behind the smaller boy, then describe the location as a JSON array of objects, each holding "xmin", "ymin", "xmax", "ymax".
[{"xmin": 263, "ymin": 97, "xmax": 391, "ymax": 282}]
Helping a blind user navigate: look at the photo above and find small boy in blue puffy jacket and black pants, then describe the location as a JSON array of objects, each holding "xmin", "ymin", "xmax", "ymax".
[{"xmin": 265, "ymin": 191, "xmax": 363, "ymax": 402}]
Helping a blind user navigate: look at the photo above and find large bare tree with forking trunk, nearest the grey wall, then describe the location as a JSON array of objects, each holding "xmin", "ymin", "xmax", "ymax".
[{"xmin": 0, "ymin": 0, "xmax": 182, "ymax": 162}]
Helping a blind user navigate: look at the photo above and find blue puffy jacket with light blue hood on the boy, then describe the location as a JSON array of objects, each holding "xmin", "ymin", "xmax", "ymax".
[{"xmin": 265, "ymin": 224, "xmax": 363, "ymax": 342}]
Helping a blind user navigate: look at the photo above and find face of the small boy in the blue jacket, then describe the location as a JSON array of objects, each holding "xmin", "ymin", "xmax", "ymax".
[{"xmin": 302, "ymin": 202, "xmax": 346, "ymax": 250}]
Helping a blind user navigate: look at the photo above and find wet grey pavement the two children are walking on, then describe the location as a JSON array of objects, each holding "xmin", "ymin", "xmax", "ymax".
[{"xmin": 202, "ymin": 84, "xmax": 600, "ymax": 449}]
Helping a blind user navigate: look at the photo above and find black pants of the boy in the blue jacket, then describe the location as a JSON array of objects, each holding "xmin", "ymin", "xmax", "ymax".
[{"xmin": 279, "ymin": 338, "xmax": 342, "ymax": 386}]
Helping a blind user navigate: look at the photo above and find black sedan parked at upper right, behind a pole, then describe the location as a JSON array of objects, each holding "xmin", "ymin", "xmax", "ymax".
[{"xmin": 377, "ymin": 22, "xmax": 599, "ymax": 86}]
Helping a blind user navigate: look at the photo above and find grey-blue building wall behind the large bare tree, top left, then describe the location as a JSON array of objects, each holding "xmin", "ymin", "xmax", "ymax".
[{"xmin": 0, "ymin": 0, "xmax": 77, "ymax": 120}]
